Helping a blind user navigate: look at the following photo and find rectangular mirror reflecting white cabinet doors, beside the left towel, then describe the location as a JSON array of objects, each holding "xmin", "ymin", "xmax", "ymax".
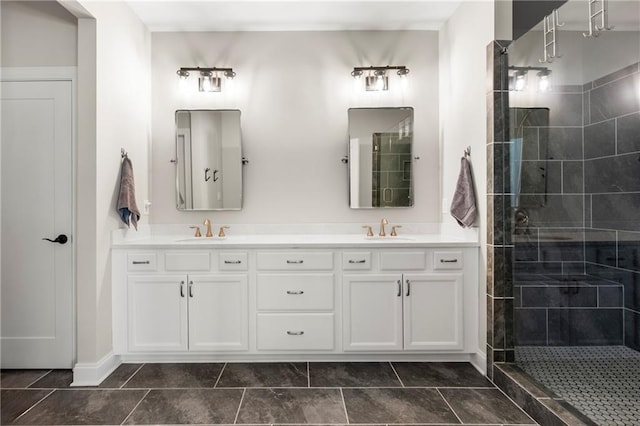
[{"xmin": 176, "ymin": 110, "xmax": 242, "ymax": 210}]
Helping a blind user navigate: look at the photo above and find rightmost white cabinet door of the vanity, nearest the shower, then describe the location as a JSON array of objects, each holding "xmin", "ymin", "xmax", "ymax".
[{"xmin": 404, "ymin": 274, "xmax": 463, "ymax": 350}]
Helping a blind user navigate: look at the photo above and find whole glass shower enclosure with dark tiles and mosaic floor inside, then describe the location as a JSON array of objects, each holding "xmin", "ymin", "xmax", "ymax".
[{"xmin": 507, "ymin": 0, "xmax": 640, "ymax": 425}]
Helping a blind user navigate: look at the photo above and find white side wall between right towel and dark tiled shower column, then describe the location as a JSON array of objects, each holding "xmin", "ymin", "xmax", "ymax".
[{"xmin": 439, "ymin": 1, "xmax": 494, "ymax": 352}]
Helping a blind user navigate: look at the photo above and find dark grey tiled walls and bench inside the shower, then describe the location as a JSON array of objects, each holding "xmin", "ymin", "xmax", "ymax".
[{"xmin": 510, "ymin": 64, "xmax": 640, "ymax": 349}]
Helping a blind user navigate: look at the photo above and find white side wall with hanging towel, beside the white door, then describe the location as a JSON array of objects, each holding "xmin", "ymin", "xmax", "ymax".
[{"xmin": 78, "ymin": 1, "xmax": 151, "ymax": 363}]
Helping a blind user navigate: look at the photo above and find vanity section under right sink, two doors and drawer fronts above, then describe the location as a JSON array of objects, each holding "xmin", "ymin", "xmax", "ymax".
[{"xmin": 342, "ymin": 250, "xmax": 464, "ymax": 352}]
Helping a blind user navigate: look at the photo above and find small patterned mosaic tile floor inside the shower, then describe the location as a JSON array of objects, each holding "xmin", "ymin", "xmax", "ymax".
[{"xmin": 516, "ymin": 346, "xmax": 640, "ymax": 426}]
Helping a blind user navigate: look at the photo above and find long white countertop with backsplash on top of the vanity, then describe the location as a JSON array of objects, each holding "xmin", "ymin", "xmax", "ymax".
[{"xmin": 112, "ymin": 224, "xmax": 480, "ymax": 249}]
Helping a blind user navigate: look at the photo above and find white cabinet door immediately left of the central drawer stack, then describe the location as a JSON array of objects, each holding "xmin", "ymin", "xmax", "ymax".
[{"xmin": 187, "ymin": 275, "xmax": 249, "ymax": 351}]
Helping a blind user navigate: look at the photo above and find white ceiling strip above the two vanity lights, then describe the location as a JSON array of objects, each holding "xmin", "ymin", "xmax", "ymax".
[{"xmin": 127, "ymin": 0, "xmax": 469, "ymax": 31}]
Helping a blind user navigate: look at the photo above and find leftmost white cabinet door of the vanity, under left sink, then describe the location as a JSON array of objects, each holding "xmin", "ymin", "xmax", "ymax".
[{"xmin": 127, "ymin": 275, "xmax": 187, "ymax": 352}]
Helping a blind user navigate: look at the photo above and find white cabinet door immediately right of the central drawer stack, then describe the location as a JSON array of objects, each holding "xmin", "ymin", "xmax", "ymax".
[{"xmin": 343, "ymin": 274, "xmax": 402, "ymax": 351}]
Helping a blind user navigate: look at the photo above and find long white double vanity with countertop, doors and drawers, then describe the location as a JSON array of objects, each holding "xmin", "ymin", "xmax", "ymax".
[{"xmin": 112, "ymin": 225, "xmax": 479, "ymax": 362}]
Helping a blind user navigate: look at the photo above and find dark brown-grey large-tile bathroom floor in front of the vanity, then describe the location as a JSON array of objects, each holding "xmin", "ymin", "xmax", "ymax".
[{"xmin": 0, "ymin": 362, "xmax": 536, "ymax": 425}]
